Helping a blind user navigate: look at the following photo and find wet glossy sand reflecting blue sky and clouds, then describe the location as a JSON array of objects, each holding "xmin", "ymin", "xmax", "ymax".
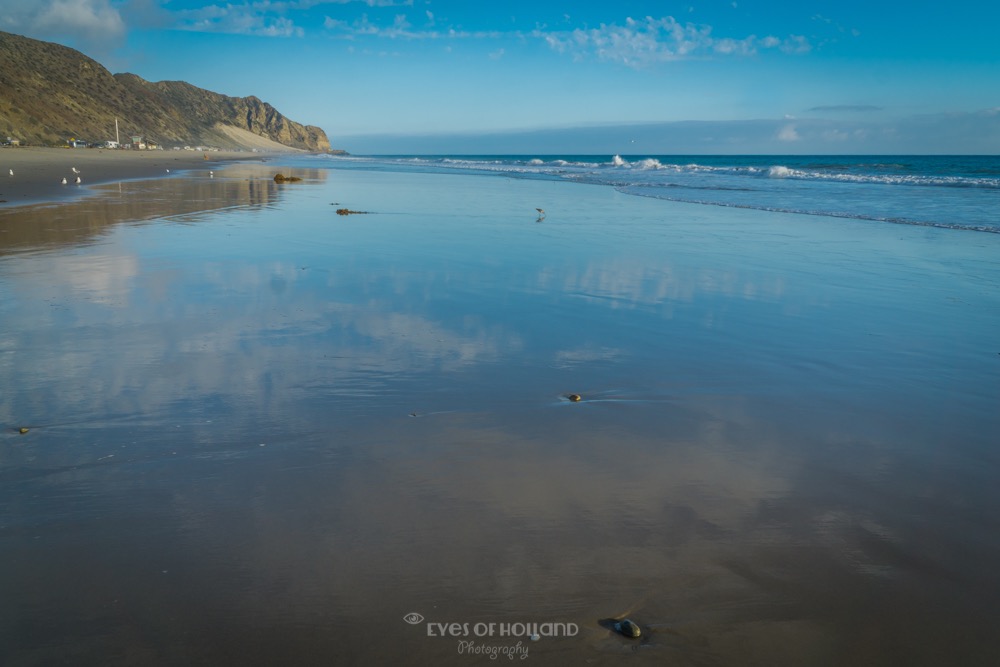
[{"xmin": 0, "ymin": 158, "xmax": 1000, "ymax": 667}]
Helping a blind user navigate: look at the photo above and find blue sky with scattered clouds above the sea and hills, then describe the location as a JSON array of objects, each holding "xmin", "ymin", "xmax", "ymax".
[{"xmin": 0, "ymin": 0, "xmax": 1000, "ymax": 154}]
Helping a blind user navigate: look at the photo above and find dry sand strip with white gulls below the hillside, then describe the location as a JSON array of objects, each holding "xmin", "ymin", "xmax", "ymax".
[{"xmin": 0, "ymin": 147, "xmax": 286, "ymax": 208}]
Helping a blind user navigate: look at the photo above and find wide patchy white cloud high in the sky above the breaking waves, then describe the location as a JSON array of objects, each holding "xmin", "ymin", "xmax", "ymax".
[{"xmin": 533, "ymin": 16, "xmax": 811, "ymax": 67}]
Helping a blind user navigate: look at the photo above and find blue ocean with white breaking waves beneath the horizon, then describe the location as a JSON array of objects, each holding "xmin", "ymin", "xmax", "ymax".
[{"xmin": 316, "ymin": 155, "xmax": 1000, "ymax": 233}]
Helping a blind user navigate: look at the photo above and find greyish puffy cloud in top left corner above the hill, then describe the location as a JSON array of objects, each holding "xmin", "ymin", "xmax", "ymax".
[{"xmin": 0, "ymin": 0, "xmax": 125, "ymax": 51}]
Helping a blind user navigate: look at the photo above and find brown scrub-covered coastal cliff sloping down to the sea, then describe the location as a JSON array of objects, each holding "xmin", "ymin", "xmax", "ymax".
[{"xmin": 0, "ymin": 32, "xmax": 330, "ymax": 151}]
